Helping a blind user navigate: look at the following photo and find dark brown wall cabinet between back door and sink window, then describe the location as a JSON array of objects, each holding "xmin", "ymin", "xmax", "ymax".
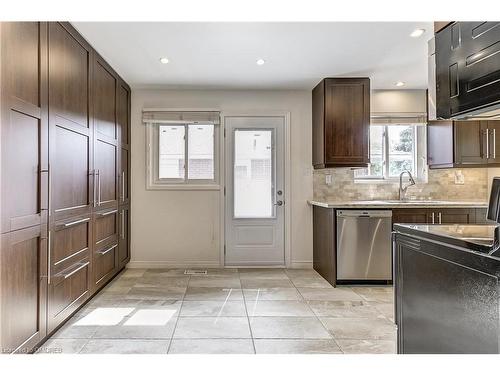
[{"xmin": 312, "ymin": 78, "xmax": 370, "ymax": 169}]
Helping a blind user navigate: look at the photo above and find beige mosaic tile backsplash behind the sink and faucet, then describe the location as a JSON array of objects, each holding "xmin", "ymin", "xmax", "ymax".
[{"xmin": 313, "ymin": 168, "xmax": 488, "ymax": 201}]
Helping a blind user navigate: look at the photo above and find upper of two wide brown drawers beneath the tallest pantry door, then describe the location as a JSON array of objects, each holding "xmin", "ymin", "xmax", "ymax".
[{"xmin": 50, "ymin": 216, "xmax": 92, "ymax": 275}]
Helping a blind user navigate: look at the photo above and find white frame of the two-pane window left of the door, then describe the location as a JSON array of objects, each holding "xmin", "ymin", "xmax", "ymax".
[{"xmin": 146, "ymin": 121, "xmax": 221, "ymax": 190}]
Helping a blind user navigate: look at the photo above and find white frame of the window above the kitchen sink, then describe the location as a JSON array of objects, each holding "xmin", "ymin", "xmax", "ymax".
[{"xmin": 354, "ymin": 124, "xmax": 427, "ymax": 182}]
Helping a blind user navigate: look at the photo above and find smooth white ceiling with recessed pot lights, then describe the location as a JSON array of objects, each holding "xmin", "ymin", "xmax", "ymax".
[{"xmin": 73, "ymin": 22, "xmax": 432, "ymax": 89}]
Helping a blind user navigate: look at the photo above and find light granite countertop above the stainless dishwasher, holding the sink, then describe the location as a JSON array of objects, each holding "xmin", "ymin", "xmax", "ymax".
[{"xmin": 308, "ymin": 200, "xmax": 488, "ymax": 208}]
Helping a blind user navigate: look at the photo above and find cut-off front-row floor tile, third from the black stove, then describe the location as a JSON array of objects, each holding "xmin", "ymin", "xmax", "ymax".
[{"xmin": 168, "ymin": 339, "xmax": 254, "ymax": 354}]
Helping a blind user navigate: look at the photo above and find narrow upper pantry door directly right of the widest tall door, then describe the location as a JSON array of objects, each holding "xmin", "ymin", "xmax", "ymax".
[{"xmin": 92, "ymin": 57, "xmax": 119, "ymax": 209}]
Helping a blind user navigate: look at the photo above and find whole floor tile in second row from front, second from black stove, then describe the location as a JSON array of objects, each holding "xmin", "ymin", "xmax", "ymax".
[{"xmin": 250, "ymin": 317, "xmax": 331, "ymax": 339}]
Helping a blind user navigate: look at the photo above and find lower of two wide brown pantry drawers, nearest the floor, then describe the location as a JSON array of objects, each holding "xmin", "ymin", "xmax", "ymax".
[{"xmin": 49, "ymin": 258, "xmax": 90, "ymax": 330}]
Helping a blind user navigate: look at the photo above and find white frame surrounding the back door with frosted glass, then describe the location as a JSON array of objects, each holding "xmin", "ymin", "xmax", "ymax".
[{"xmin": 219, "ymin": 110, "xmax": 292, "ymax": 268}]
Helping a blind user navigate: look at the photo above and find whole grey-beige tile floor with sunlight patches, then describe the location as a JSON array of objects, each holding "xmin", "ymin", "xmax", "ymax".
[{"xmin": 35, "ymin": 269, "xmax": 396, "ymax": 354}]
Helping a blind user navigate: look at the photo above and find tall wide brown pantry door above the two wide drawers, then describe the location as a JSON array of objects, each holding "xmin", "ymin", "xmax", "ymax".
[{"xmin": 49, "ymin": 22, "xmax": 93, "ymax": 220}]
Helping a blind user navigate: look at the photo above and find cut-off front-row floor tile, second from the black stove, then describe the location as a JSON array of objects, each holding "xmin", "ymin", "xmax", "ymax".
[{"xmin": 254, "ymin": 339, "xmax": 342, "ymax": 354}]
